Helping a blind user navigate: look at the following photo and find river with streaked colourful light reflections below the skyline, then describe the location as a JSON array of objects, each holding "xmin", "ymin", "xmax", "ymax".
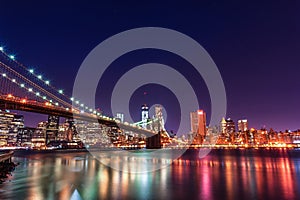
[{"xmin": 0, "ymin": 149, "xmax": 300, "ymax": 200}]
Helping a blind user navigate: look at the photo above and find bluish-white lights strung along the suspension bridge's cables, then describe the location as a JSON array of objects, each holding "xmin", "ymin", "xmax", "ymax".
[{"xmin": 0, "ymin": 46, "xmax": 102, "ymax": 116}]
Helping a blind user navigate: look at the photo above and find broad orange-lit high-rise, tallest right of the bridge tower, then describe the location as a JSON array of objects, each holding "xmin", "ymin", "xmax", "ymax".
[{"xmin": 190, "ymin": 110, "xmax": 206, "ymax": 136}]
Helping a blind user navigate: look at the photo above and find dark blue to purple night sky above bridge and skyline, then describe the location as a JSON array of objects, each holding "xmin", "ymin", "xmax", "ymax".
[{"xmin": 0, "ymin": 0, "xmax": 300, "ymax": 130}]
